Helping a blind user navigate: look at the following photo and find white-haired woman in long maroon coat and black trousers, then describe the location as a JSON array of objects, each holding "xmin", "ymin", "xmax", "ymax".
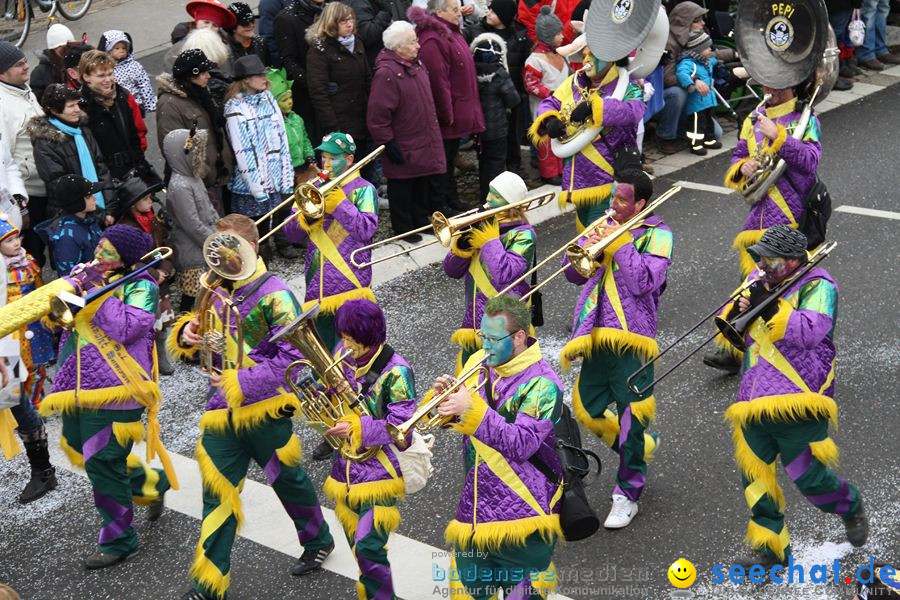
[{"xmin": 367, "ymin": 21, "xmax": 446, "ymax": 242}]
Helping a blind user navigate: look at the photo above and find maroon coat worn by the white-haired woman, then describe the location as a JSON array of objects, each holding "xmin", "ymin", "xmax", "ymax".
[{"xmin": 366, "ymin": 48, "xmax": 447, "ymax": 179}]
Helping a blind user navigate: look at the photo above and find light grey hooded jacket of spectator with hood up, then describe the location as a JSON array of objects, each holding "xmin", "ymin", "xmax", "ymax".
[{"xmin": 163, "ymin": 129, "xmax": 219, "ymax": 270}]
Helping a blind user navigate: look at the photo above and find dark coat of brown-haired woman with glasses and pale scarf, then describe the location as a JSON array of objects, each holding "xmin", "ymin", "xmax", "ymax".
[{"xmin": 306, "ymin": 37, "xmax": 372, "ymax": 143}]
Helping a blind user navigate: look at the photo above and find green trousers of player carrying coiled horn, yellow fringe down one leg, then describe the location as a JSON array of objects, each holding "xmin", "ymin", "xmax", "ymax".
[{"xmin": 191, "ymin": 417, "xmax": 333, "ymax": 598}]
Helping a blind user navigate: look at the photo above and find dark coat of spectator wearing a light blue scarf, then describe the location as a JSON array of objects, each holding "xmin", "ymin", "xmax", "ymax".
[{"xmin": 27, "ymin": 117, "xmax": 118, "ymax": 214}]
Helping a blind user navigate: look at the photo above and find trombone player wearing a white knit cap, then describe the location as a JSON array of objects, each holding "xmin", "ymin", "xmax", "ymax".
[{"xmin": 444, "ymin": 171, "xmax": 535, "ymax": 372}]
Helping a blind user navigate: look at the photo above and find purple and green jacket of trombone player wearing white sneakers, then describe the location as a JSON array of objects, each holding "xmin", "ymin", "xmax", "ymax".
[{"xmin": 563, "ymin": 216, "xmax": 673, "ymax": 365}]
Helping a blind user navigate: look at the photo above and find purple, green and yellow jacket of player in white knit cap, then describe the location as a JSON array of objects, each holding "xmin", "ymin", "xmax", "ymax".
[{"xmin": 444, "ymin": 221, "xmax": 535, "ymax": 373}]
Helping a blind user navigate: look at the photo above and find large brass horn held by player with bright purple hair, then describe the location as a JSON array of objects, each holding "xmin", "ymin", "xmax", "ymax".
[{"xmin": 272, "ymin": 304, "xmax": 380, "ymax": 462}]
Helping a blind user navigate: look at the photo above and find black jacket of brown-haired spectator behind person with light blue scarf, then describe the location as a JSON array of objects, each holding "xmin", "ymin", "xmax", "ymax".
[{"xmin": 81, "ymin": 85, "xmax": 151, "ymax": 179}]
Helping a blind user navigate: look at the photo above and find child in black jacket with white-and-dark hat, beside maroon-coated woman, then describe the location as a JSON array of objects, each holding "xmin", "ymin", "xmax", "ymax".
[{"xmin": 470, "ymin": 33, "xmax": 519, "ymax": 202}]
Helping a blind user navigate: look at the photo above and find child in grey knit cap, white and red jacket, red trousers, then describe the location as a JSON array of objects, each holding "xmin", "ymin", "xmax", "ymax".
[{"xmin": 522, "ymin": 6, "xmax": 569, "ymax": 185}]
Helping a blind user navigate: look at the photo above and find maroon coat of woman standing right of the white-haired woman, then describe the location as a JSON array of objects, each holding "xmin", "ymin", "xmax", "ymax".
[{"xmin": 406, "ymin": 7, "xmax": 484, "ymax": 140}]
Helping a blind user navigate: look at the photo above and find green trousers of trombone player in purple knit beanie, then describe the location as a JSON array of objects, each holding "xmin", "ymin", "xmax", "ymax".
[{"xmin": 60, "ymin": 408, "xmax": 169, "ymax": 554}]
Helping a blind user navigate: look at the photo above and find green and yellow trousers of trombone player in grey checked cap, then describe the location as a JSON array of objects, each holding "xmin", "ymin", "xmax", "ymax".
[{"xmin": 735, "ymin": 419, "xmax": 860, "ymax": 559}]
